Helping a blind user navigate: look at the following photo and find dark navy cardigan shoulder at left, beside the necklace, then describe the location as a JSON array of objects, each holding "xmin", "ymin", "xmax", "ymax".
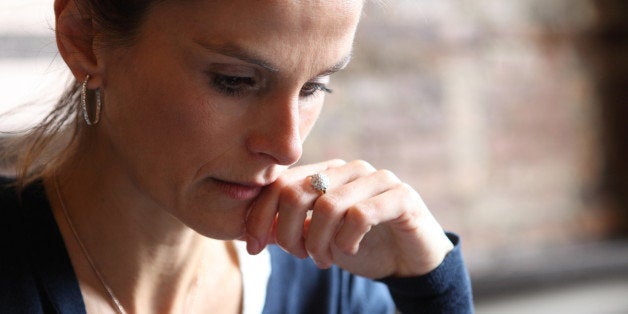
[{"xmin": 0, "ymin": 178, "xmax": 84, "ymax": 313}]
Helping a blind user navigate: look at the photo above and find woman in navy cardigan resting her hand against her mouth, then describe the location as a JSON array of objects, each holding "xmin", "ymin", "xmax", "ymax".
[{"xmin": 0, "ymin": 0, "xmax": 472, "ymax": 313}]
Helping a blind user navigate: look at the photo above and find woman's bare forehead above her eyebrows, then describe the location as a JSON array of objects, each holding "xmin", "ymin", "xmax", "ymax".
[{"xmin": 139, "ymin": 0, "xmax": 362, "ymax": 69}]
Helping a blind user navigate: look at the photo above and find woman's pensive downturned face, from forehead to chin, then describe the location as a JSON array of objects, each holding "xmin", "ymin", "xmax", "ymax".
[{"xmin": 97, "ymin": 0, "xmax": 362, "ymax": 239}]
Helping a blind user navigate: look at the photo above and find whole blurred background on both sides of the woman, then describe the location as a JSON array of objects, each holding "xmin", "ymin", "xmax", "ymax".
[{"xmin": 0, "ymin": 0, "xmax": 628, "ymax": 313}]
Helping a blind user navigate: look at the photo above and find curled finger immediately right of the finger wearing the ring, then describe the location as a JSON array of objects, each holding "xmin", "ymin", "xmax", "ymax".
[{"xmin": 306, "ymin": 170, "xmax": 399, "ymax": 266}]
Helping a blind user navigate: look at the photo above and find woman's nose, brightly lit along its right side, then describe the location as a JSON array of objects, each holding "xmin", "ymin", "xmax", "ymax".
[{"xmin": 247, "ymin": 96, "xmax": 303, "ymax": 166}]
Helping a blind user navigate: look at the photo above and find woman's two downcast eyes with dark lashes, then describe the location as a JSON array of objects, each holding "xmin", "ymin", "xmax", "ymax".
[{"xmin": 211, "ymin": 74, "xmax": 332, "ymax": 99}]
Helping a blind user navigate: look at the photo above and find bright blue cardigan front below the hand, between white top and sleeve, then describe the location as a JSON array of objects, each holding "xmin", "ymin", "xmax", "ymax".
[{"xmin": 264, "ymin": 245, "xmax": 394, "ymax": 313}]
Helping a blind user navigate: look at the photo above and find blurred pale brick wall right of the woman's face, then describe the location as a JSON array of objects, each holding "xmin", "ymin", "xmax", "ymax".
[{"xmin": 305, "ymin": 0, "xmax": 613, "ymax": 273}]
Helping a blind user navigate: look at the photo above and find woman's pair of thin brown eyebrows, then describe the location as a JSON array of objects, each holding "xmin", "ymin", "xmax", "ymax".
[{"xmin": 197, "ymin": 42, "xmax": 352, "ymax": 76}]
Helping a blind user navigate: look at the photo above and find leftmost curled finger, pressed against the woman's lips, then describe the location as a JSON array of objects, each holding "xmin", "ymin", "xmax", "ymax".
[{"xmin": 246, "ymin": 159, "xmax": 345, "ymax": 254}]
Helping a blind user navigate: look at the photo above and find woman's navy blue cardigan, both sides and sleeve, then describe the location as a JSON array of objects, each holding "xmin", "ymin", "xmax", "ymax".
[{"xmin": 0, "ymin": 179, "xmax": 473, "ymax": 314}]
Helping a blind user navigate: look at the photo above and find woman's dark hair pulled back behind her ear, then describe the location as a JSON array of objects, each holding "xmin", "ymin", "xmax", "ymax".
[{"xmin": 0, "ymin": 0, "xmax": 165, "ymax": 188}]
